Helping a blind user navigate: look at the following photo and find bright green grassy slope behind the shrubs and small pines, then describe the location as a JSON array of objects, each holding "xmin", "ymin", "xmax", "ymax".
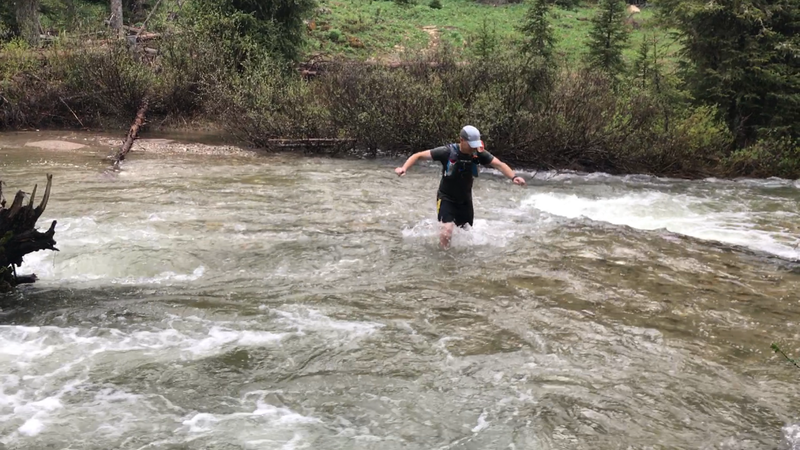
[{"xmin": 305, "ymin": 0, "xmax": 678, "ymax": 66}]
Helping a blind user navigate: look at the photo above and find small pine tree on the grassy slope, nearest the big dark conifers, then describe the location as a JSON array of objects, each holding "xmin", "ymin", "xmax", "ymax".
[{"xmin": 587, "ymin": 0, "xmax": 630, "ymax": 75}]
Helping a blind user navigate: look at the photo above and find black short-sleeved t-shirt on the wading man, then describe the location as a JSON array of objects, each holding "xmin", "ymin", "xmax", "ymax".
[{"xmin": 431, "ymin": 144, "xmax": 494, "ymax": 203}]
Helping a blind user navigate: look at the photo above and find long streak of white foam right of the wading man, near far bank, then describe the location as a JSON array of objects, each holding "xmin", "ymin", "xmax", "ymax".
[{"xmin": 522, "ymin": 192, "xmax": 800, "ymax": 259}]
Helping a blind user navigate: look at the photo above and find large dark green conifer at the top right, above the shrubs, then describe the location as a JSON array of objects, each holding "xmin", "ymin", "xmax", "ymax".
[{"xmin": 661, "ymin": 0, "xmax": 800, "ymax": 146}]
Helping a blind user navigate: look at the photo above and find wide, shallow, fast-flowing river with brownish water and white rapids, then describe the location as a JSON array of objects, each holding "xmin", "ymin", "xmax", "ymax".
[{"xmin": 0, "ymin": 132, "xmax": 800, "ymax": 450}]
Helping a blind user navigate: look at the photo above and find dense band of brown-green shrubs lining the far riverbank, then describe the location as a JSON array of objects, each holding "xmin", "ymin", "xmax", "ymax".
[{"xmin": 0, "ymin": 40, "xmax": 800, "ymax": 179}]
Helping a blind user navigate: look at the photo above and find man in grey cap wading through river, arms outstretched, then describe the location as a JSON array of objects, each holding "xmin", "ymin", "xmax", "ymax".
[{"xmin": 394, "ymin": 125, "xmax": 525, "ymax": 248}]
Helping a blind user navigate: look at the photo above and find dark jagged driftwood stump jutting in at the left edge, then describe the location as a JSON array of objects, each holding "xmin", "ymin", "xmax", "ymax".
[{"xmin": 0, "ymin": 174, "xmax": 58, "ymax": 292}]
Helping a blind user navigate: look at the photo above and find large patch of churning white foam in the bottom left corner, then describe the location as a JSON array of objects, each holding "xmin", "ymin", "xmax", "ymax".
[{"xmin": 0, "ymin": 306, "xmax": 385, "ymax": 448}]
